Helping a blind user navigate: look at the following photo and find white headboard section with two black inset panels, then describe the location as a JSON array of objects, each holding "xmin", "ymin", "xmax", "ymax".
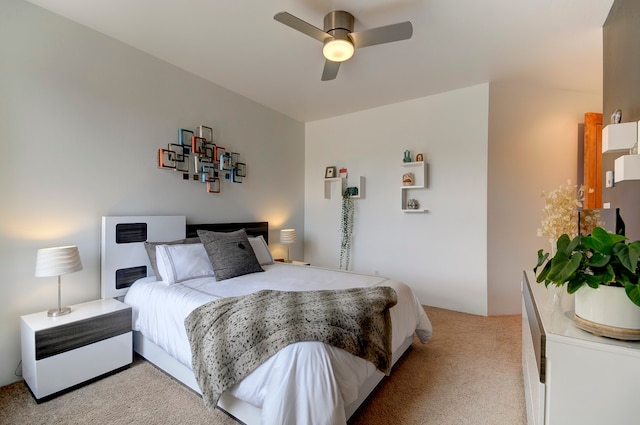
[{"xmin": 100, "ymin": 216, "xmax": 186, "ymax": 298}]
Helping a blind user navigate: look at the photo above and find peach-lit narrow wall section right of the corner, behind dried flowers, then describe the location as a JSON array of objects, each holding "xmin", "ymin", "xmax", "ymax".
[{"xmin": 487, "ymin": 82, "xmax": 602, "ymax": 315}]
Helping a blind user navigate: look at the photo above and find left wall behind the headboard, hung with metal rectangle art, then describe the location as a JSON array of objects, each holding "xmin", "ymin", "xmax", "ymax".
[{"xmin": 0, "ymin": 0, "xmax": 304, "ymax": 385}]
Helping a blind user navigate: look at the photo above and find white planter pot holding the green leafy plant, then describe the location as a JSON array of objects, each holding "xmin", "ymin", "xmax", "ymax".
[{"xmin": 575, "ymin": 285, "xmax": 640, "ymax": 329}]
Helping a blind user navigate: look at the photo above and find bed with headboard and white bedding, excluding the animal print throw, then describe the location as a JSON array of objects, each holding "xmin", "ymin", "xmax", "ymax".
[{"xmin": 101, "ymin": 216, "xmax": 432, "ymax": 425}]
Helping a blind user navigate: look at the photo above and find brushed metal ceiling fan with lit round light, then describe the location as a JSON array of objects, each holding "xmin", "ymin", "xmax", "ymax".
[{"xmin": 273, "ymin": 10, "xmax": 413, "ymax": 81}]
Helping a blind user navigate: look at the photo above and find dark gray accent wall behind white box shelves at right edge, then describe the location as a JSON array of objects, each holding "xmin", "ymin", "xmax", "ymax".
[{"xmin": 602, "ymin": 0, "xmax": 640, "ymax": 240}]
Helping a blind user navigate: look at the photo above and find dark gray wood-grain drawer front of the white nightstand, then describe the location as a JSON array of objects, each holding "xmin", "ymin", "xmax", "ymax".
[{"xmin": 35, "ymin": 308, "xmax": 131, "ymax": 360}]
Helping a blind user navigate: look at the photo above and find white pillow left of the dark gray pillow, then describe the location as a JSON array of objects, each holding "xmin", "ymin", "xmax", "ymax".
[{"xmin": 156, "ymin": 243, "xmax": 214, "ymax": 285}]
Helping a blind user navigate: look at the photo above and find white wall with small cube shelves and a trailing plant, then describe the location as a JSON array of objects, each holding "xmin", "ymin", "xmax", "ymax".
[{"xmin": 305, "ymin": 84, "xmax": 489, "ymax": 314}]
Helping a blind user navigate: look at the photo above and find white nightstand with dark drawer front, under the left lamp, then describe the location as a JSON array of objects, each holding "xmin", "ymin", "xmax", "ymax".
[{"xmin": 20, "ymin": 299, "xmax": 133, "ymax": 402}]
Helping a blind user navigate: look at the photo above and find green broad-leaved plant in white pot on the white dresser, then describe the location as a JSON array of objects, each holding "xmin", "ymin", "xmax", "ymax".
[{"xmin": 533, "ymin": 227, "xmax": 640, "ymax": 339}]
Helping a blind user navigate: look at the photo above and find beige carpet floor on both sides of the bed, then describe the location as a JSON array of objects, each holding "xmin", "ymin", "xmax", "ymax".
[{"xmin": 0, "ymin": 307, "xmax": 526, "ymax": 425}]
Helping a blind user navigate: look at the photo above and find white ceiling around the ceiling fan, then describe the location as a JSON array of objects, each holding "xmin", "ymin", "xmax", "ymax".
[{"xmin": 29, "ymin": 0, "xmax": 613, "ymax": 122}]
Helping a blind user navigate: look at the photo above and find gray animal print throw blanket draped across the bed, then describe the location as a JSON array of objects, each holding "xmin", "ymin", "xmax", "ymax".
[{"xmin": 185, "ymin": 287, "xmax": 397, "ymax": 409}]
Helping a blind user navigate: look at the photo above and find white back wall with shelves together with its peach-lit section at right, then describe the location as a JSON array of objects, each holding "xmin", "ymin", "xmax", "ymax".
[{"xmin": 305, "ymin": 82, "xmax": 602, "ymax": 315}]
